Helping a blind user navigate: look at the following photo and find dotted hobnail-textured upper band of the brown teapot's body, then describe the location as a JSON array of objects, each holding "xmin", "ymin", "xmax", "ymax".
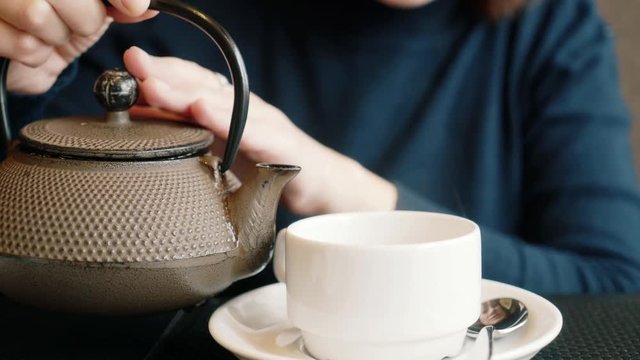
[{"xmin": 0, "ymin": 154, "xmax": 238, "ymax": 263}]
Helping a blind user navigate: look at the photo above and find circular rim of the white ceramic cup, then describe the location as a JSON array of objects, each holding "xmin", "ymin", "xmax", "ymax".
[{"xmin": 285, "ymin": 210, "xmax": 480, "ymax": 251}]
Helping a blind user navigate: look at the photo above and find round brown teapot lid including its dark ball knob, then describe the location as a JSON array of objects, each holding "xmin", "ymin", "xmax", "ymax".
[{"xmin": 20, "ymin": 69, "xmax": 213, "ymax": 160}]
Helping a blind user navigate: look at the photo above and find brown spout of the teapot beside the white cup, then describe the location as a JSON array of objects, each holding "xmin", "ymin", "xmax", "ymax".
[{"xmin": 229, "ymin": 164, "xmax": 300, "ymax": 278}]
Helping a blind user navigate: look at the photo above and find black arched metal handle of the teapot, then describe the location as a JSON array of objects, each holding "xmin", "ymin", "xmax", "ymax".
[{"xmin": 0, "ymin": 0, "xmax": 250, "ymax": 172}]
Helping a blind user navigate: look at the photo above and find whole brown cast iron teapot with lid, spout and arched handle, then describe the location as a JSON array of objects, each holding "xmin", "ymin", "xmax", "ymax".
[{"xmin": 0, "ymin": 0, "xmax": 300, "ymax": 314}]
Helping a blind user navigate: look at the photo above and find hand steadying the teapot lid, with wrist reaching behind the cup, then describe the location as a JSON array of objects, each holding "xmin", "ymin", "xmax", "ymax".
[{"xmin": 124, "ymin": 47, "xmax": 397, "ymax": 215}]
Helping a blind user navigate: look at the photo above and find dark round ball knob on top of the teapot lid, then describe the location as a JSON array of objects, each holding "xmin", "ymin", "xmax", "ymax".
[{"xmin": 93, "ymin": 68, "xmax": 139, "ymax": 113}]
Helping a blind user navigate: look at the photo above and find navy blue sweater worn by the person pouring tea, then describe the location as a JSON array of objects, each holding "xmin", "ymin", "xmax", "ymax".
[{"xmin": 6, "ymin": 0, "xmax": 640, "ymax": 293}]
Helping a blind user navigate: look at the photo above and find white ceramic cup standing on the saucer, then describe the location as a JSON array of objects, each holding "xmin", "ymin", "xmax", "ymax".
[{"xmin": 274, "ymin": 211, "xmax": 482, "ymax": 360}]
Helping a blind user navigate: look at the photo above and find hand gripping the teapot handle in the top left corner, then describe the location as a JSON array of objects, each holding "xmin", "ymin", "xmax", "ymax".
[{"xmin": 0, "ymin": 0, "xmax": 155, "ymax": 95}]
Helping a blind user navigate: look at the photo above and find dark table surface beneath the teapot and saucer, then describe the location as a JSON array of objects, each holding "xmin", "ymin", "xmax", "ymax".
[{"xmin": 0, "ymin": 284, "xmax": 640, "ymax": 360}]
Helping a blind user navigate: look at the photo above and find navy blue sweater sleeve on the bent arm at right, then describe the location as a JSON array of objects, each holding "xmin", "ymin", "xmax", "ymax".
[{"xmin": 398, "ymin": 0, "xmax": 640, "ymax": 293}]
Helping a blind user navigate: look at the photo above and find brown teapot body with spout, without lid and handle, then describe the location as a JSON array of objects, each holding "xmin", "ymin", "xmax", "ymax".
[{"xmin": 0, "ymin": 151, "xmax": 297, "ymax": 314}]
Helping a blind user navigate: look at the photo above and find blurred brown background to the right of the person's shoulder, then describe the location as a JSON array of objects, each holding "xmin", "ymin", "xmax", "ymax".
[{"xmin": 598, "ymin": 0, "xmax": 640, "ymax": 173}]
